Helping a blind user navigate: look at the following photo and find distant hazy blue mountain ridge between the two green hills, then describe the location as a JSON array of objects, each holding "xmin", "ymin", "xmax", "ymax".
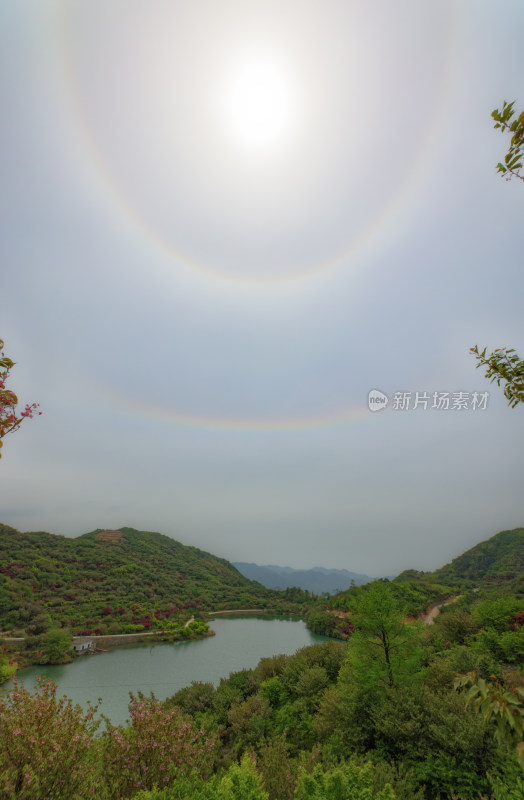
[{"xmin": 233, "ymin": 561, "xmax": 373, "ymax": 595}]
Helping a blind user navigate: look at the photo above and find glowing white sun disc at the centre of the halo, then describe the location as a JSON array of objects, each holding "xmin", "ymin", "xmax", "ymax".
[{"xmin": 226, "ymin": 58, "xmax": 293, "ymax": 148}]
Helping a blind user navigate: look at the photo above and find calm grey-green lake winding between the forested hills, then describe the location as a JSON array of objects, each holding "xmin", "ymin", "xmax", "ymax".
[{"xmin": 0, "ymin": 615, "xmax": 328, "ymax": 724}]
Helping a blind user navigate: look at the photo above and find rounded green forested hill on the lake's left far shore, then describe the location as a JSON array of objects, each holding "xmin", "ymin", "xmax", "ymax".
[{"xmin": 0, "ymin": 525, "xmax": 302, "ymax": 633}]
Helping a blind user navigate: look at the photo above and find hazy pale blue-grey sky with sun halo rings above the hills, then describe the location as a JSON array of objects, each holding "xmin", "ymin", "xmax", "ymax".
[{"xmin": 0, "ymin": 0, "xmax": 524, "ymax": 575}]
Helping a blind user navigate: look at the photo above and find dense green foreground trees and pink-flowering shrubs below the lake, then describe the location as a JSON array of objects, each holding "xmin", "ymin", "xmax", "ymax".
[{"xmin": 0, "ymin": 581, "xmax": 524, "ymax": 800}]
